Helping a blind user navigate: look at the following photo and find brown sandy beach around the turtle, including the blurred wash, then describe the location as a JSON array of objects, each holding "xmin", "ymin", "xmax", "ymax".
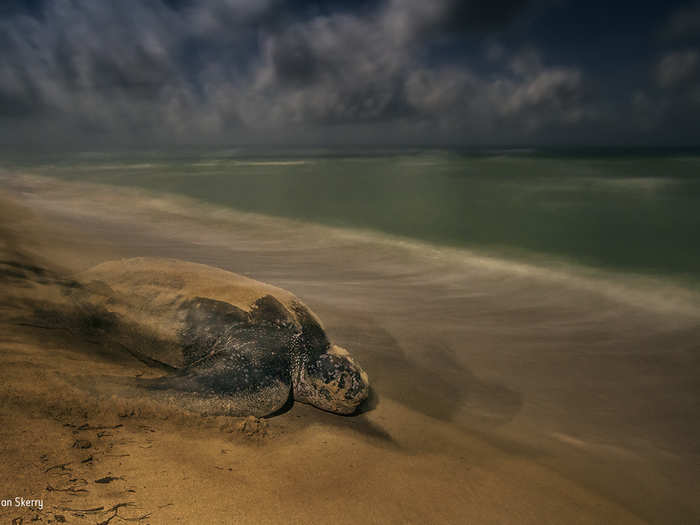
[{"xmin": 0, "ymin": 177, "xmax": 700, "ymax": 523}]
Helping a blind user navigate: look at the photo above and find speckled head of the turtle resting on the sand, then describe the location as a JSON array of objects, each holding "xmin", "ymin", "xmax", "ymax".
[{"xmin": 294, "ymin": 345, "xmax": 369, "ymax": 414}]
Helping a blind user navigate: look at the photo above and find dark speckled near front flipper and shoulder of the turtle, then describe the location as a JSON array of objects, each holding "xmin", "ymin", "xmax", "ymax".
[{"xmin": 140, "ymin": 296, "xmax": 297, "ymax": 417}]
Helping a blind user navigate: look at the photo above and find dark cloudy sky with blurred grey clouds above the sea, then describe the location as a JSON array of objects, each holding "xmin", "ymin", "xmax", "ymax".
[{"xmin": 0, "ymin": 0, "xmax": 700, "ymax": 148}]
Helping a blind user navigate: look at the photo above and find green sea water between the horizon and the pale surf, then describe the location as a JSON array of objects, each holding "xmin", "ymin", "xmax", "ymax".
[{"xmin": 2, "ymin": 151, "xmax": 700, "ymax": 282}]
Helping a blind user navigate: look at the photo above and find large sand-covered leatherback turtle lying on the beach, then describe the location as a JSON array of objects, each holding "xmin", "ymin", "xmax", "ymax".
[{"xmin": 74, "ymin": 258, "xmax": 369, "ymax": 417}]
